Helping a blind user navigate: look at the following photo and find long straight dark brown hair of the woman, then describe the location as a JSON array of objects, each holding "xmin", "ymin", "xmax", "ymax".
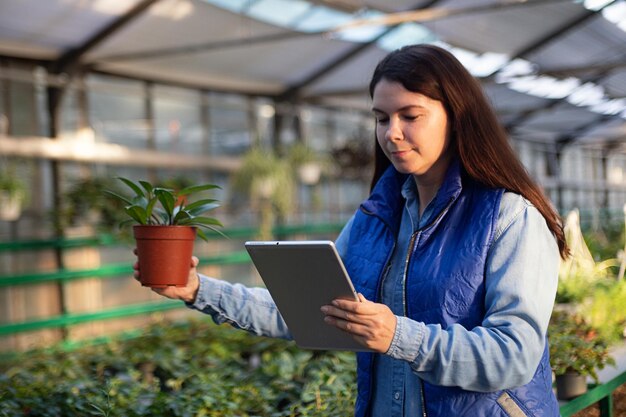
[{"xmin": 369, "ymin": 45, "xmax": 569, "ymax": 258}]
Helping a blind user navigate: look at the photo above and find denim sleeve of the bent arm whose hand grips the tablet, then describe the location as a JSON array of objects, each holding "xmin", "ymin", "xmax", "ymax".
[{"xmin": 387, "ymin": 193, "xmax": 560, "ymax": 392}]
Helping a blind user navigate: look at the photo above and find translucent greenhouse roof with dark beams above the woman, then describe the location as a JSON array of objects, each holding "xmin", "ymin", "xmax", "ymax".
[{"xmin": 0, "ymin": 0, "xmax": 626, "ymax": 149}]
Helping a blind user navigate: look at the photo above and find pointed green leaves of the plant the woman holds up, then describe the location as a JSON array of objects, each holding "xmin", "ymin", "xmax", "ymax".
[{"xmin": 105, "ymin": 177, "xmax": 222, "ymax": 240}]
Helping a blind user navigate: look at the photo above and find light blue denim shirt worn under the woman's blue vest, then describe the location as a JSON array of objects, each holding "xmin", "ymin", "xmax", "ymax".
[{"xmin": 188, "ymin": 184, "xmax": 559, "ymax": 416}]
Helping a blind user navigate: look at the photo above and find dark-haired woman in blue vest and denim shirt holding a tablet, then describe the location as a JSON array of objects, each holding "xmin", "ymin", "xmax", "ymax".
[{"xmin": 136, "ymin": 45, "xmax": 568, "ymax": 417}]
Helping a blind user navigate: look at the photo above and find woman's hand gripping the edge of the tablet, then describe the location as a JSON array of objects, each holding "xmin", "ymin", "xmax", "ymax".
[{"xmin": 322, "ymin": 294, "xmax": 397, "ymax": 353}]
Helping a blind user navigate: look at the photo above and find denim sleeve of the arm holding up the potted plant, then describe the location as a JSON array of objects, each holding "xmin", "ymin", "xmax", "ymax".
[{"xmin": 187, "ymin": 274, "xmax": 292, "ymax": 339}]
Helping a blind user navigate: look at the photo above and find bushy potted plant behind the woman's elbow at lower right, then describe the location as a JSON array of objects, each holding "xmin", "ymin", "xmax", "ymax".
[{"xmin": 548, "ymin": 311, "xmax": 615, "ymax": 400}]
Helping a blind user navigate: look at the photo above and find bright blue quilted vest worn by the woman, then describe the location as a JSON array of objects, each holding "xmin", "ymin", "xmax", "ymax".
[{"xmin": 344, "ymin": 161, "xmax": 559, "ymax": 417}]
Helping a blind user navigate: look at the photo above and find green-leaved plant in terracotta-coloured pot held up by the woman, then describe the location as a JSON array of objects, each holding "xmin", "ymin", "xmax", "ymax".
[{"xmin": 105, "ymin": 177, "xmax": 222, "ymax": 287}]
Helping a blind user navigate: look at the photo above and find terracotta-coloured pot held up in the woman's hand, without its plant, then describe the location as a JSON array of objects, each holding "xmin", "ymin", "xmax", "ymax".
[{"xmin": 133, "ymin": 226, "xmax": 196, "ymax": 288}]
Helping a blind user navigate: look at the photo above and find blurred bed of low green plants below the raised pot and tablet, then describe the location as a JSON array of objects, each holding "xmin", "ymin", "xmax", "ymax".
[{"xmin": 0, "ymin": 320, "xmax": 355, "ymax": 417}]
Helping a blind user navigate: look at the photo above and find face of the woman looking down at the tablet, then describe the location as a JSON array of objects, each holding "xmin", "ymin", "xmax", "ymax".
[{"xmin": 372, "ymin": 78, "xmax": 450, "ymax": 184}]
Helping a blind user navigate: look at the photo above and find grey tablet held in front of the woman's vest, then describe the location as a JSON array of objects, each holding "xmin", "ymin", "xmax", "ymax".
[{"xmin": 245, "ymin": 240, "xmax": 368, "ymax": 351}]
